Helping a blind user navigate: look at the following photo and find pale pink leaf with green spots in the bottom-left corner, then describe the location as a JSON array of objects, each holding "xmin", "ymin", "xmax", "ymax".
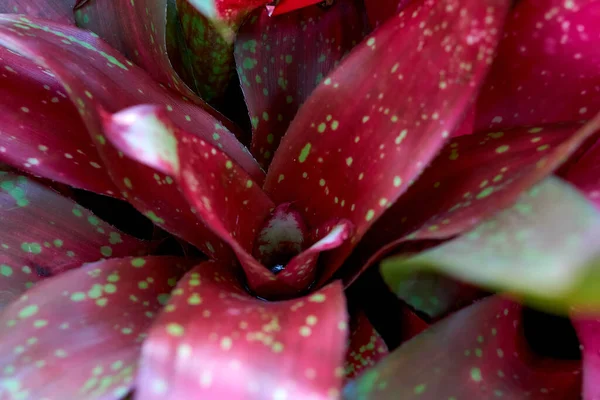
[{"xmin": 0, "ymin": 257, "xmax": 191, "ymax": 399}]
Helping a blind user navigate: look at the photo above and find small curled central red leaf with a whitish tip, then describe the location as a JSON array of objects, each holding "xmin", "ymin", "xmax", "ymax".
[{"xmin": 105, "ymin": 106, "xmax": 351, "ymax": 297}]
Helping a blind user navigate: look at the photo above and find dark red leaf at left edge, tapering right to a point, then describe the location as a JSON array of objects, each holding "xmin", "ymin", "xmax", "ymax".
[{"xmin": 0, "ymin": 47, "xmax": 119, "ymax": 197}]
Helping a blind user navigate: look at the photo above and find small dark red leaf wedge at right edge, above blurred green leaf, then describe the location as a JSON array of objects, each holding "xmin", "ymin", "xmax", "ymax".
[{"xmin": 561, "ymin": 137, "xmax": 600, "ymax": 208}]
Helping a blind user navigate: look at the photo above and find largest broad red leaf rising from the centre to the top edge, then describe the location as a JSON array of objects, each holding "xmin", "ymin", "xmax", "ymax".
[{"xmin": 265, "ymin": 0, "xmax": 509, "ymax": 284}]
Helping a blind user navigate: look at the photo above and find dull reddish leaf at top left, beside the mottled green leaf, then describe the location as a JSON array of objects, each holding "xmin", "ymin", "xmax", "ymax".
[{"xmin": 75, "ymin": 0, "xmax": 197, "ymax": 100}]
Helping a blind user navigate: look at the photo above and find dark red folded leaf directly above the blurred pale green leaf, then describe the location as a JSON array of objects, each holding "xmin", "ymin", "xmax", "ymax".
[{"xmin": 346, "ymin": 115, "xmax": 600, "ymax": 288}]
